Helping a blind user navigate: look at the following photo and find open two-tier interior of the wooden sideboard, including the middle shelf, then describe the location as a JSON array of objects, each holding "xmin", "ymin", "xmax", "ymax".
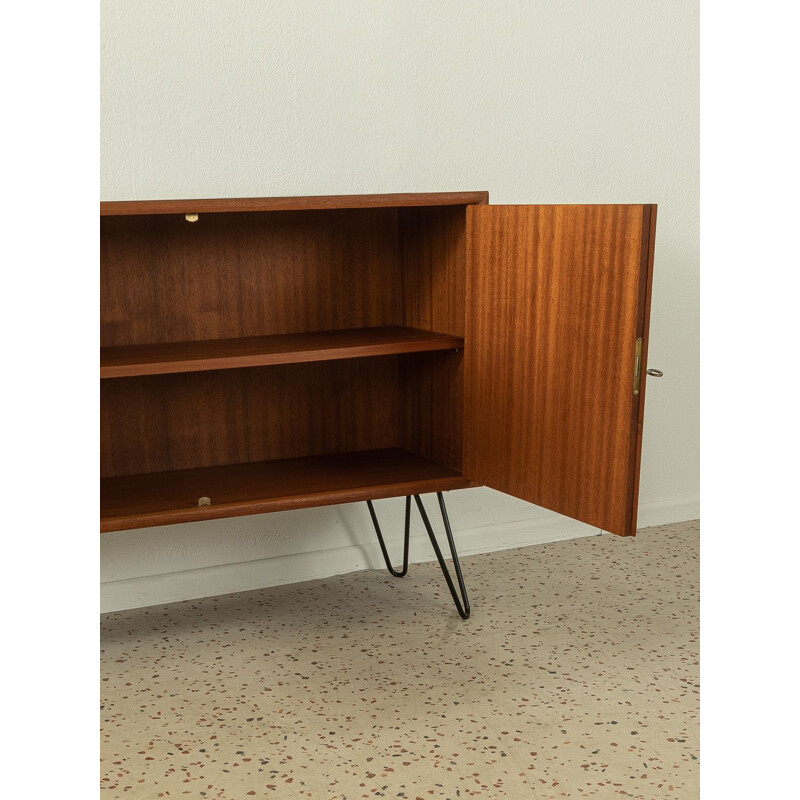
[{"xmin": 101, "ymin": 205, "xmax": 466, "ymax": 529}]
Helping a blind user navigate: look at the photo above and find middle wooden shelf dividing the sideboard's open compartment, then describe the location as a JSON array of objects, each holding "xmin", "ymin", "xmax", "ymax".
[{"xmin": 100, "ymin": 327, "xmax": 464, "ymax": 378}]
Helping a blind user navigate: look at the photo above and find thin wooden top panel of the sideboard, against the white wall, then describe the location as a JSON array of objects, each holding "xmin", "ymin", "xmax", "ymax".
[{"xmin": 100, "ymin": 192, "xmax": 489, "ymax": 217}]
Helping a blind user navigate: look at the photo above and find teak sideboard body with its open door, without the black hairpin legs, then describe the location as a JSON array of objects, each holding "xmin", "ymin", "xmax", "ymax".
[{"xmin": 100, "ymin": 192, "xmax": 655, "ymax": 552}]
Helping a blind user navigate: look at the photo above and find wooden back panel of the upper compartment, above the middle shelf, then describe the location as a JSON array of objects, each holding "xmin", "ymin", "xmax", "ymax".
[{"xmin": 101, "ymin": 208, "xmax": 404, "ymax": 347}]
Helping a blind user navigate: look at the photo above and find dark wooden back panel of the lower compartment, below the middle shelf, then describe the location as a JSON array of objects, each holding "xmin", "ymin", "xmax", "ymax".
[{"xmin": 100, "ymin": 356, "xmax": 403, "ymax": 477}]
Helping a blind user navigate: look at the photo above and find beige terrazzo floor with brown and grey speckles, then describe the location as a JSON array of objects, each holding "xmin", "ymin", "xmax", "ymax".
[{"xmin": 101, "ymin": 521, "xmax": 699, "ymax": 800}]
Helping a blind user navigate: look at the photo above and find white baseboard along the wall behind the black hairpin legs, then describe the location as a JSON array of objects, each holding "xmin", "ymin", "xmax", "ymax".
[{"xmin": 100, "ymin": 496, "xmax": 700, "ymax": 613}]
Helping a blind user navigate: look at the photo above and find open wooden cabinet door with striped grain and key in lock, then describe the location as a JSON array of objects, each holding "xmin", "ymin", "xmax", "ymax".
[{"xmin": 464, "ymin": 205, "xmax": 656, "ymax": 535}]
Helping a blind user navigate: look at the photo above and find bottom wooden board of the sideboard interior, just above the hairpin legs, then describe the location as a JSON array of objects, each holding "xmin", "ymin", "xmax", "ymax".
[{"xmin": 100, "ymin": 448, "xmax": 472, "ymax": 532}]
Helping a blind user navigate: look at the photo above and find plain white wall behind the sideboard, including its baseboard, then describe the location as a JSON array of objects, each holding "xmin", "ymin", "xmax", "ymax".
[{"xmin": 101, "ymin": 0, "xmax": 699, "ymax": 610}]
